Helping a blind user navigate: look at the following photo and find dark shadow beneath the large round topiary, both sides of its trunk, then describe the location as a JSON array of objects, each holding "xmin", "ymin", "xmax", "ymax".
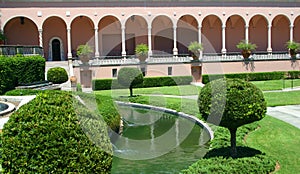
[{"xmin": 203, "ymin": 146, "xmax": 263, "ymax": 159}]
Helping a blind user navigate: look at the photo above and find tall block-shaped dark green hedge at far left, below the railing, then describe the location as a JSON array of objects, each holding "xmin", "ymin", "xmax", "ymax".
[{"xmin": 0, "ymin": 56, "xmax": 45, "ymax": 94}]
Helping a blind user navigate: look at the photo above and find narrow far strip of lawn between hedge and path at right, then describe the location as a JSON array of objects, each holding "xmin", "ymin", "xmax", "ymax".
[{"xmin": 251, "ymin": 79, "xmax": 300, "ymax": 91}]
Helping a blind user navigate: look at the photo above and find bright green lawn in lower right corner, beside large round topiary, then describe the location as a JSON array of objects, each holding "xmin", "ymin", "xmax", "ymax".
[{"xmin": 246, "ymin": 117, "xmax": 300, "ymax": 173}]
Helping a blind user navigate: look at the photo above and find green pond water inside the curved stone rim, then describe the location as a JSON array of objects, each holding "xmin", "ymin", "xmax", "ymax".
[{"xmin": 112, "ymin": 107, "xmax": 209, "ymax": 174}]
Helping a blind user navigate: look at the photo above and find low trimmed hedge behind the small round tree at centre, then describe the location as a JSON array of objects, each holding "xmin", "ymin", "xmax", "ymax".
[{"xmin": 92, "ymin": 76, "xmax": 193, "ymax": 91}]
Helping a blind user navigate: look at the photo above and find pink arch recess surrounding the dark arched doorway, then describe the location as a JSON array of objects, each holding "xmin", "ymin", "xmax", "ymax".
[{"xmin": 43, "ymin": 16, "xmax": 67, "ymax": 60}]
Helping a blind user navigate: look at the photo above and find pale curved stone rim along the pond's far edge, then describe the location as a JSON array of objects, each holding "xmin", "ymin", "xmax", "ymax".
[{"xmin": 115, "ymin": 101, "xmax": 214, "ymax": 140}]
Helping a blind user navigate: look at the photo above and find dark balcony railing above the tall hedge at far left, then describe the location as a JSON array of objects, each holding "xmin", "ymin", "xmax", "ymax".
[{"xmin": 0, "ymin": 45, "xmax": 43, "ymax": 56}]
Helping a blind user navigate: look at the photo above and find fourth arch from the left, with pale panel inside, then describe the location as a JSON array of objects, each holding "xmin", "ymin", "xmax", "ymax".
[{"xmin": 98, "ymin": 15, "xmax": 122, "ymax": 56}]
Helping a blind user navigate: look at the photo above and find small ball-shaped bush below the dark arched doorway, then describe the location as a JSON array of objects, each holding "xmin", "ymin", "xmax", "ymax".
[{"xmin": 47, "ymin": 67, "xmax": 68, "ymax": 84}]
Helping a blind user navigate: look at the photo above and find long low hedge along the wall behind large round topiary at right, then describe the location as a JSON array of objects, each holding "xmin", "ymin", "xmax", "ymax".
[{"xmin": 202, "ymin": 71, "xmax": 290, "ymax": 84}]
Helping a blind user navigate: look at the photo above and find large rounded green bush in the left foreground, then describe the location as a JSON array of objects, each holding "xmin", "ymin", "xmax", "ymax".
[{"xmin": 1, "ymin": 91, "xmax": 112, "ymax": 173}]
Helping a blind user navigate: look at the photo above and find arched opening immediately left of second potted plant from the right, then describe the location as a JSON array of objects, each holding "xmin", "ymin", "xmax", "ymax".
[{"xmin": 225, "ymin": 15, "xmax": 246, "ymax": 52}]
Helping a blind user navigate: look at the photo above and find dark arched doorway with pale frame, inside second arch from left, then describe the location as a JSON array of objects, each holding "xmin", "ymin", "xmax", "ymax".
[{"xmin": 48, "ymin": 37, "xmax": 66, "ymax": 61}]
